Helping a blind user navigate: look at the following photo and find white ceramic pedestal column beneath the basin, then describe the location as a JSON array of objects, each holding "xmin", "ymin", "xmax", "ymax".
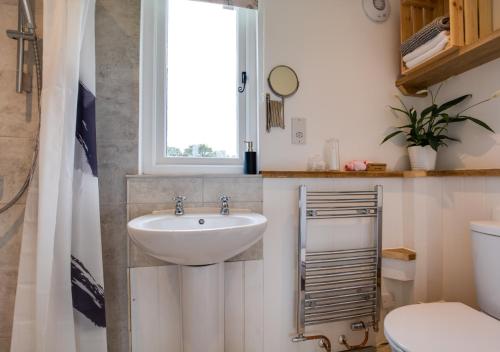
[{"xmin": 181, "ymin": 263, "xmax": 224, "ymax": 352}]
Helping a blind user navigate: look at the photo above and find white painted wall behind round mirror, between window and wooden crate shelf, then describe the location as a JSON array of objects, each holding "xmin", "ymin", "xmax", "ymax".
[{"xmin": 259, "ymin": 0, "xmax": 408, "ymax": 170}]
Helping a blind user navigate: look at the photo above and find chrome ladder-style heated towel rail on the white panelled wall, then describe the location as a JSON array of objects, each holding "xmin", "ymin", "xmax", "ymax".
[{"xmin": 294, "ymin": 186, "xmax": 382, "ymax": 341}]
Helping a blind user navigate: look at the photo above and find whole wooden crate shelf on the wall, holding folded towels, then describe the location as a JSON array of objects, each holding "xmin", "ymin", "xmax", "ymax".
[{"xmin": 396, "ymin": 0, "xmax": 500, "ymax": 95}]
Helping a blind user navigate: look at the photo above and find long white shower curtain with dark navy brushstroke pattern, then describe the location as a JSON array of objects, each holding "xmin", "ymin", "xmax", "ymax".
[{"xmin": 11, "ymin": 0, "xmax": 106, "ymax": 352}]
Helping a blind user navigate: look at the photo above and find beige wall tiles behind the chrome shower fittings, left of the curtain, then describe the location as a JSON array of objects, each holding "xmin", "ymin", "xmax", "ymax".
[{"xmin": 0, "ymin": 0, "xmax": 42, "ymax": 352}]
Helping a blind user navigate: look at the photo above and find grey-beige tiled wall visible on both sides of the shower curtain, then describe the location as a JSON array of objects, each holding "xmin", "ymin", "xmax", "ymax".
[{"xmin": 0, "ymin": 0, "xmax": 140, "ymax": 352}]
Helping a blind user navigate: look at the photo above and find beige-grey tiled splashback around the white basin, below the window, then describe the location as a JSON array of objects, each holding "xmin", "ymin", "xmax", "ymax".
[{"xmin": 127, "ymin": 176, "xmax": 262, "ymax": 267}]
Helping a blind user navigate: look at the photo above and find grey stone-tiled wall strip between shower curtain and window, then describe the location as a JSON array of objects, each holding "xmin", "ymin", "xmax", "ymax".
[{"xmin": 96, "ymin": 0, "xmax": 140, "ymax": 352}]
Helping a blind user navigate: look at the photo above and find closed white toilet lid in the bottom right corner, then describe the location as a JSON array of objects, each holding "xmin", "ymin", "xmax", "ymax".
[{"xmin": 384, "ymin": 302, "xmax": 500, "ymax": 352}]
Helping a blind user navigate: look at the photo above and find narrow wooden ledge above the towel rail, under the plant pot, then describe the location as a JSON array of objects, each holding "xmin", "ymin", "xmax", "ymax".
[{"xmin": 261, "ymin": 169, "xmax": 500, "ymax": 178}]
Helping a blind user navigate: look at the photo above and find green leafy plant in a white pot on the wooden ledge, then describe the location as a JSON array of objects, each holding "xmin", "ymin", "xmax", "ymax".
[{"xmin": 382, "ymin": 85, "xmax": 500, "ymax": 170}]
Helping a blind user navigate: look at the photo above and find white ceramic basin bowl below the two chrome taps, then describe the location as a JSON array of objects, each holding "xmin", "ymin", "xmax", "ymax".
[{"xmin": 127, "ymin": 213, "xmax": 267, "ymax": 265}]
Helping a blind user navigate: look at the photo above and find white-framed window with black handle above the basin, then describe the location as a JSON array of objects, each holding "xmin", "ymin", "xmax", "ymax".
[{"xmin": 140, "ymin": 0, "xmax": 257, "ymax": 173}]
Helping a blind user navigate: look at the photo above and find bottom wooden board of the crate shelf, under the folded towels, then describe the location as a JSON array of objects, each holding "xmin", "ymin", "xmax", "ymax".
[{"xmin": 396, "ymin": 30, "xmax": 500, "ymax": 95}]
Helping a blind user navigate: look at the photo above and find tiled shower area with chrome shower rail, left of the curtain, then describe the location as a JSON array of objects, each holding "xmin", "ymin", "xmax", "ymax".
[{"xmin": 0, "ymin": 0, "xmax": 42, "ymax": 351}]
